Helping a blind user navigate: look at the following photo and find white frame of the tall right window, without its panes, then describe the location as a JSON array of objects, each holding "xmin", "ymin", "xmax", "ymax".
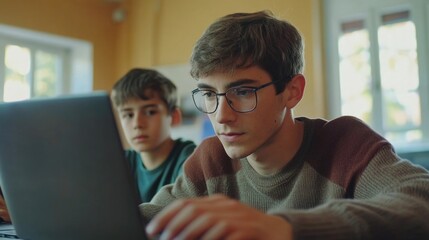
[{"xmin": 323, "ymin": 0, "xmax": 429, "ymax": 152}]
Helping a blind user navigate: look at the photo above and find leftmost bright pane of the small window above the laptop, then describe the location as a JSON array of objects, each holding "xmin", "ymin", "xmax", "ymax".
[{"xmin": 3, "ymin": 45, "xmax": 31, "ymax": 102}]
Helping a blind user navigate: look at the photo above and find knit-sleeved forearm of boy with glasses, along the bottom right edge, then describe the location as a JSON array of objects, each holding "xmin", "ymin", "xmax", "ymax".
[{"xmin": 275, "ymin": 191, "xmax": 429, "ymax": 240}]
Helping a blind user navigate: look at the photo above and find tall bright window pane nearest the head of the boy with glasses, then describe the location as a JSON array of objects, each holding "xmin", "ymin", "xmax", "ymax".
[{"xmin": 338, "ymin": 29, "xmax": 373, "ymax": 124}]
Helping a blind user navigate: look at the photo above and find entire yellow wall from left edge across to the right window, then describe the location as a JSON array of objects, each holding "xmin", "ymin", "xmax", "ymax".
[{"xmin": 0, "ymin": 0, "xmax": 326, "ymax": 117}]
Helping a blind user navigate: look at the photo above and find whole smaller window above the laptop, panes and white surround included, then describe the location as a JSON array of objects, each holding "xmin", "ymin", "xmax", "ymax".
[{"xmin": 0, "ymin": 25, "xmax": 92, "ymax": 102}]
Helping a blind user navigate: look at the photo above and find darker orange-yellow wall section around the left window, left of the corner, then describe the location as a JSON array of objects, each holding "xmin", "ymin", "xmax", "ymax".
[{"xmin": 0, "ymin": 0, "xmax": 119, "ymax": 90}]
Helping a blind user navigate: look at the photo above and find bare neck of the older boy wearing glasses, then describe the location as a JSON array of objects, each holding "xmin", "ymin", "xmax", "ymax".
[{"xmin": 247, "ymin": 114, "xmax": 304, "ymax": 176}]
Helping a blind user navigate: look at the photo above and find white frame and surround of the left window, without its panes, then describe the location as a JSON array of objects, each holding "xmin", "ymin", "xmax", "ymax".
[{"xmin": 0, "ymin": 24, "xmax": 93, "ymax": 99}]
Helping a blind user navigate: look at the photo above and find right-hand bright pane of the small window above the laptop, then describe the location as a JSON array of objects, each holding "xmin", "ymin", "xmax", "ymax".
[{"xmin": 34, "ymin": 51, "xmax": 61, "ymax": 97}]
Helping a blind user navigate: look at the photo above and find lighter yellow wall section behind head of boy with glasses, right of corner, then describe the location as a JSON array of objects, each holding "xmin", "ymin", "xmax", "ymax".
[{"xmin": 119, "ymin": 0, "xmax": 325, "ymax": 117}]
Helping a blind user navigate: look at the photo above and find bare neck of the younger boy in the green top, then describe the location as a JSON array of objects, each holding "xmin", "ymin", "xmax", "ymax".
[{"xmin": 140, "ymin": 138, "xmax": 174, "ymax": 170}]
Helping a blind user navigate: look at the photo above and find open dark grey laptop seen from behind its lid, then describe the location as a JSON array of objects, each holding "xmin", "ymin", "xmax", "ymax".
[{"xmin": 0, "ymin": 92, "xmax": 147, "ymax": 240}]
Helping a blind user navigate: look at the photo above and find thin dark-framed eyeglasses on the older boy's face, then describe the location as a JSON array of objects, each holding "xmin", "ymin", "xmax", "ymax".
[{"xmin": 192, "ymin": 81, "xmax": 275, "ymax": 114}]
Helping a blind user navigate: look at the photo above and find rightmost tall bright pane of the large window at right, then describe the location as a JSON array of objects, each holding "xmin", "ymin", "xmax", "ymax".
[{"xmin": 378, "ymin": 21, "xmax": 422, "ymax": 141}]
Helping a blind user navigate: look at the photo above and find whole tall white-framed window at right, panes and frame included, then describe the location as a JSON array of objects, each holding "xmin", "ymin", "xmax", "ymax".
[{"xmin": 324, "ymin": 0, "xmax": 429, "ymax": 155}]
